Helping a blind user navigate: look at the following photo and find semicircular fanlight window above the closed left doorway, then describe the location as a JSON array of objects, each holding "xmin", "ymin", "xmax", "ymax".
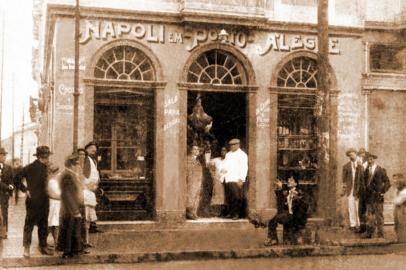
[{"xmin": 94, "ymin": 46, "xmax": 155, "ymax": 81}]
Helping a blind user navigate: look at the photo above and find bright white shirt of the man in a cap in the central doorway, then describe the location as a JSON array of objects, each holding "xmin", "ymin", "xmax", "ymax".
[{"xmin": 225, "ymin": 148, "xmax": 248, "ymax": 183}]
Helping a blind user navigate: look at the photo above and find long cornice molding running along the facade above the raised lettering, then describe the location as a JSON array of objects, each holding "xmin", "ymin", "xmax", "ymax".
[{"xmin": 48, "ymin": 4, "xmax": 365, "ymax": 37}]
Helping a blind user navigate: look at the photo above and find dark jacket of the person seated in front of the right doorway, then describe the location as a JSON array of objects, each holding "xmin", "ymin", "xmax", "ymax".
[{"xmin": 275, "ymin": 189, "xmax": 309, "ymax": 230}]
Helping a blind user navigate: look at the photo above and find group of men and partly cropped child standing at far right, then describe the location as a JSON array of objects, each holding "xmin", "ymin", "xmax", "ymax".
[{"xmin": 342, "ymin": 148, "xmax": 406, "ymax": 238}]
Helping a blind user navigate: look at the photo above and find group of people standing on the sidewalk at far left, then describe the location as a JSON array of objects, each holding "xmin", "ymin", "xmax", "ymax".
[{"xmin": 0, "ymin": 142, "xmax": 102, "ymax": 258}]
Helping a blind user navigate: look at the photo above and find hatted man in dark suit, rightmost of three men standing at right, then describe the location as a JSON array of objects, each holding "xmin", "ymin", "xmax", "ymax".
[{"xmin": 360, "ymin": 153, "xmax": 390, "ymax": 238}]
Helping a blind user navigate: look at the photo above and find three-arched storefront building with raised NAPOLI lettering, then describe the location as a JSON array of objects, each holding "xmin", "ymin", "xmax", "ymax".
[{"xmin": 33, "ymin": 1, "xmax": 406, "ymax": 223}]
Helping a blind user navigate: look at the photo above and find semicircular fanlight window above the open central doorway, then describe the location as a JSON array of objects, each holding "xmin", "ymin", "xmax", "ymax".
[{"xmin": 187, "ymin": 50, "xmax": 246, "ymax": 85}]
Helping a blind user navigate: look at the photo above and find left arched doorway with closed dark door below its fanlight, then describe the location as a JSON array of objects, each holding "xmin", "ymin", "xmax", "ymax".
[{"xmin": 92, "ymin": 43, "xmax": 157, "ymax": 220}]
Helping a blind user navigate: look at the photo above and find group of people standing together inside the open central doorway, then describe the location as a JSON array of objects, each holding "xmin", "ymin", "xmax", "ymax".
[{"xmin": 186, "ymin": 139, "xmax": 248, "ymax": 220}]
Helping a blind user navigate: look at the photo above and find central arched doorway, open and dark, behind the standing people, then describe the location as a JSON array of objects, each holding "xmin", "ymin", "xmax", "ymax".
[{"xmin": 180, "ymin": 46, "xmax": 255, "ymax": 217}]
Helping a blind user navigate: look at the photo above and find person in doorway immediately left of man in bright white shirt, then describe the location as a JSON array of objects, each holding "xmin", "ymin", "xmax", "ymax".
[{"xmin": 209, "ymin": 146, "xmax": 227, "ymax": 216}]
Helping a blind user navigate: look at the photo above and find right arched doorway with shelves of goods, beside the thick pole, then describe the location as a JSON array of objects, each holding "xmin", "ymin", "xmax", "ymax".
[{"xmin": 276, "ymin": 56, "xmax": 318, "ymax": 214}]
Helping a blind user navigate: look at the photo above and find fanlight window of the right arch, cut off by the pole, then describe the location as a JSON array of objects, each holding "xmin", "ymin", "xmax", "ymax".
[{"xmin": 277, "ymin": 57, "xmax": 317, "ymax": 88}]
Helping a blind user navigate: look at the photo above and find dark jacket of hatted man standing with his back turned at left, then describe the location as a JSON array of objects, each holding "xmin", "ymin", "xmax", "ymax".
[{"xmin": 18, "ymin": 159, "xmax": 48, "ymax": 209}]
